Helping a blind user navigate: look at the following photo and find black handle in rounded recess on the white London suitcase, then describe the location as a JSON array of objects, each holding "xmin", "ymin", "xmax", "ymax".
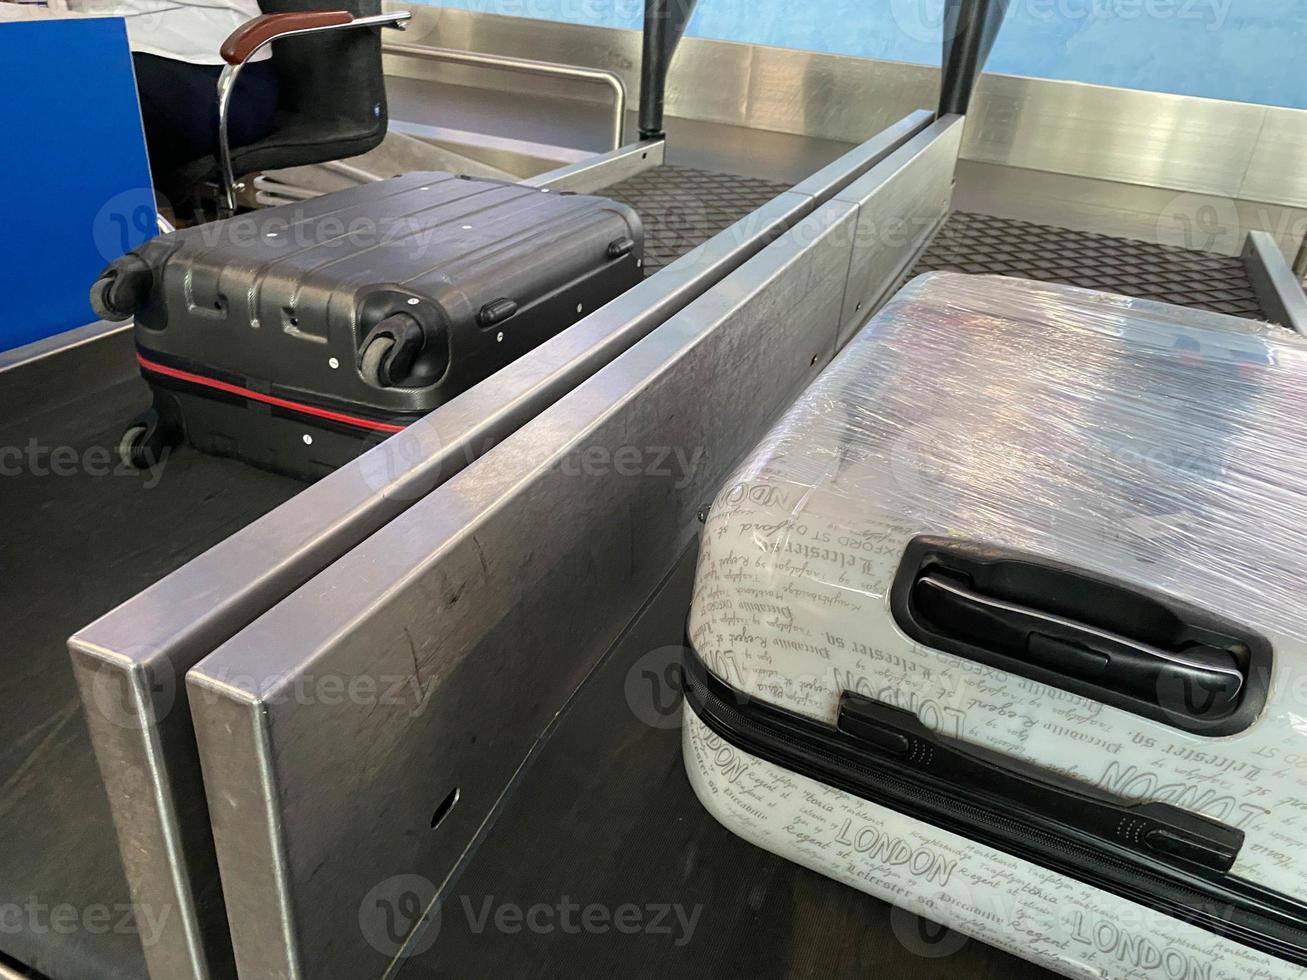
[{"xmin": 891, "ymin": 538, "xmax": 1270, "ymax": 734}]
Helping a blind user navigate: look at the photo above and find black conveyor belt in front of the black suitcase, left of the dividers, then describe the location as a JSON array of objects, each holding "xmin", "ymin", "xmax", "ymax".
[{"xmin": 0, "ymin": 341, "xmax": 302, "ymax": 980}]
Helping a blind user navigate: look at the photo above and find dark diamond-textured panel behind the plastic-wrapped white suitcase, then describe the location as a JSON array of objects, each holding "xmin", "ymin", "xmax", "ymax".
[{"xmin": 911, "ymin": 212, "xmax": 1265, "ymax": 319}]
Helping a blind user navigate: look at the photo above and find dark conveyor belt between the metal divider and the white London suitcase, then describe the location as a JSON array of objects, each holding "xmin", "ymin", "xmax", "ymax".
[{"xmin": 399, "ymin": 555, "xmax": 1051, "ymax": 980}]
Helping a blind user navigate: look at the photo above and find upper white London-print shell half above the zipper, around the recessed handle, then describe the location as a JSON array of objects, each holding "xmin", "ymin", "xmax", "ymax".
[{"xmin": 689, "ymin": 273, "xmax": 1307, "ymax": 898}]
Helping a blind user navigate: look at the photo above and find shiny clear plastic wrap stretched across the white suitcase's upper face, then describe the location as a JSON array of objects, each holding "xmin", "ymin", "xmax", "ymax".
[{"xmin": 711, "ymin": 273, "xmax": 1307, "ymax": 655}]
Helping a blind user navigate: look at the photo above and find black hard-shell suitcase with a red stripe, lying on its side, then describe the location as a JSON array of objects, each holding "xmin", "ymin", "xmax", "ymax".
[{"xmin": 91, "ymin": 172, "xmax": 643, "ymax": 478}]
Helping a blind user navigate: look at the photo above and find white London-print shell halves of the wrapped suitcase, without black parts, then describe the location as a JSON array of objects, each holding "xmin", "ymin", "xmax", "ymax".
[{"xmin": 684, "ymin": 274, "xmax": 1307, "ymax": 980}]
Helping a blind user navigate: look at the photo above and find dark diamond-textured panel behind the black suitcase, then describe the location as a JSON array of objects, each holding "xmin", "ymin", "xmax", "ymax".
[{"xmin": 600, "ymin": 165, "xmax": 789, "ymax": 276}]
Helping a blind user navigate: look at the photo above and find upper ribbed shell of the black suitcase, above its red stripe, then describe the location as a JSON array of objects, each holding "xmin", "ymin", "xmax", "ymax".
[{"xmin": 96, "ymin": 172, "xmax": 643, "ymax": 480}]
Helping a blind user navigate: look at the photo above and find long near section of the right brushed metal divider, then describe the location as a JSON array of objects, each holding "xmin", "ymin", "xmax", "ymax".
[{"xmin": 187, "ymin": 203, "xmax": 856, "ymax": 980}]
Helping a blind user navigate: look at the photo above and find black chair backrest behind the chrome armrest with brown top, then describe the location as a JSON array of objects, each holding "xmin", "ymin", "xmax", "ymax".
[{"xmin": 259, "ymin": 0, "xmax": 387, "ymax": 141}]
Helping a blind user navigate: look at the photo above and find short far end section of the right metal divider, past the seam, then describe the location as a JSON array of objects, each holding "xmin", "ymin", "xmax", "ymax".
[{"xmin": 835, "ymin": 116, "xmax": 963, "ymax": 346}]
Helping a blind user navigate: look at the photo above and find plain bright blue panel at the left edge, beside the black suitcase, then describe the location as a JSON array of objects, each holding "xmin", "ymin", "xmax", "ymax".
[{"xmin": 0, "ymin": 18, "xmax": 154, "ymax": 350}]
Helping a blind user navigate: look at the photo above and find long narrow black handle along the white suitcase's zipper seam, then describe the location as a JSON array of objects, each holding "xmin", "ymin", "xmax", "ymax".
[{"xmin": 838, "ymin": 691, "xmax": 1244, "ymax": 873}]
